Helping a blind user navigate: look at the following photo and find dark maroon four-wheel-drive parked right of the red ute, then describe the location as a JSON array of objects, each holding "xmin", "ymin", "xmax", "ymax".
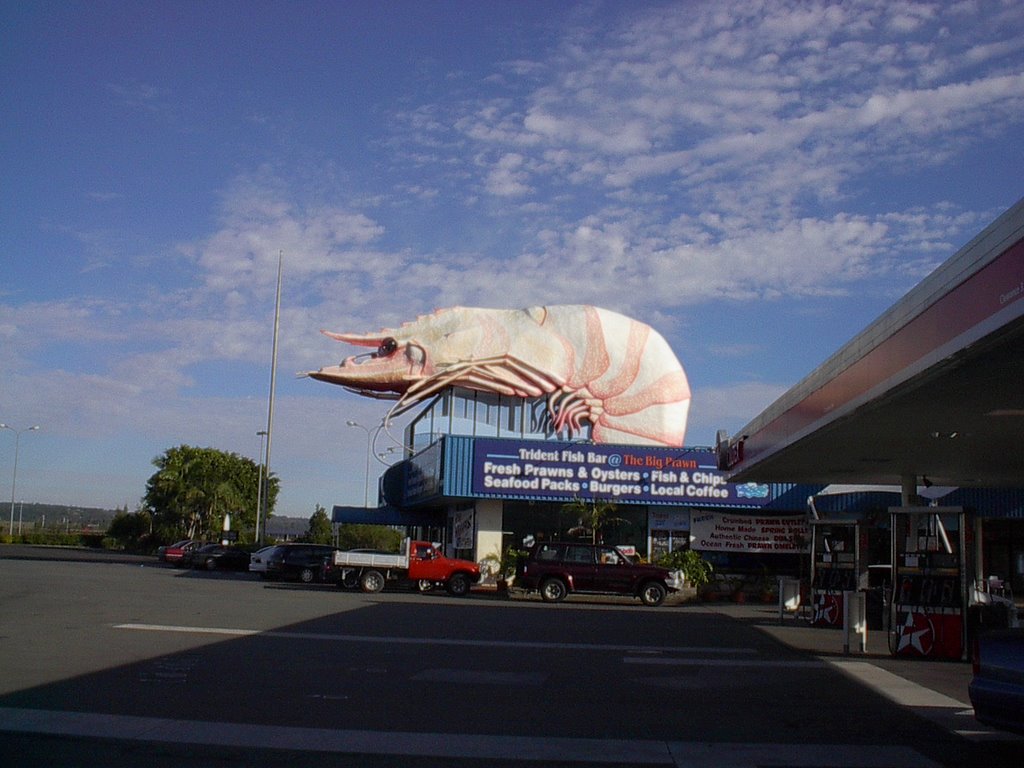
[{"xmin": 515, "ymin": 542, "xmax": 682, "ymax": 605}]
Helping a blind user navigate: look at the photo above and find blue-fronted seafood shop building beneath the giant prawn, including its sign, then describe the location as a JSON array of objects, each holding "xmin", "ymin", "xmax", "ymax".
[{"xmin": 333, "ymin": 387, "xmax": 820, "ymax": 567}]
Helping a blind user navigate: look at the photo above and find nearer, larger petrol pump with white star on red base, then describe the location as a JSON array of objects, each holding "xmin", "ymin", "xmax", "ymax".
[{"xmin": 889, "ymin": 507, "xmax": 971, "ymax": 659}]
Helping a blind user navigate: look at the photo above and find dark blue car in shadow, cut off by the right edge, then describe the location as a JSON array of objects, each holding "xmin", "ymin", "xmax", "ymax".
[{"xmin": 968, "ymin": 628, "xmax": 1024, "ymax": 733}]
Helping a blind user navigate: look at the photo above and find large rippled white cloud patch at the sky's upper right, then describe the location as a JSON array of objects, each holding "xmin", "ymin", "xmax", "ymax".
[{"xmin": 387, "ymin": 1, "xmax": 1024, "ymax": 233}]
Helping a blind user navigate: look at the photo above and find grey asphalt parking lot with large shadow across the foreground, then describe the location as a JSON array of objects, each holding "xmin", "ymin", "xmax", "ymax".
[{"xmin": 0, "ymin": 548, "xmax": 1024, "ymax": 768}]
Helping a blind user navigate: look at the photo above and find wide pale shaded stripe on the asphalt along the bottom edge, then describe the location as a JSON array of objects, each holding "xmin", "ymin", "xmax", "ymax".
[{"xmin": 0, "ymin": 708, "xmax": 939, "ymax": 768}]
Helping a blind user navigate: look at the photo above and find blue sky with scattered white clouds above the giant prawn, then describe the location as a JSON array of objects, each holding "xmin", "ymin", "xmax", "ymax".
[{"xmin": 0, "ymin": 0, "xmax": 1024, "ymax": 517}]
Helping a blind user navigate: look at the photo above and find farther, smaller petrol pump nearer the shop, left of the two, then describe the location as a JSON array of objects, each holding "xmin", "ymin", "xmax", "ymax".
[{"xmin": 809, "ymin": 520, "xmax": 867, "ymax": 627}]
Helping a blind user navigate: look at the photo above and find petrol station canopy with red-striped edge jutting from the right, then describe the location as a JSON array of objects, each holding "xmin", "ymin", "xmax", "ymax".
[{"xmin": 718, "ymin": 200, "xmax": 1024, "ymax": 487}]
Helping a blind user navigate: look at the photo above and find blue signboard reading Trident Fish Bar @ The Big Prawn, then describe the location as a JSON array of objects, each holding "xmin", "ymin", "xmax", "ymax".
[{"xmin": 473, "ymin": 438, "xmax": 771, "ymax": 507}]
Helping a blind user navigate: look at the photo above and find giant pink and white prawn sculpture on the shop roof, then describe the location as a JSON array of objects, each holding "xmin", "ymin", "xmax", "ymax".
[{"xmin": 307, "ymin": 305, "xmax": 690, "ymax": 446}]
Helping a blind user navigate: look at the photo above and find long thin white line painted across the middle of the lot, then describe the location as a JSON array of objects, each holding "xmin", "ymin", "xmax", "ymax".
[{"xmin": 114, "ymin": 624, "xmax": 758, "ymax": 655}]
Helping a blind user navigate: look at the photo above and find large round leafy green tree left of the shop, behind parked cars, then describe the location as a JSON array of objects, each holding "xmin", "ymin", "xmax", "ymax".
[{"xmin": 142, "ymin": 445, "xmax": 280, "ymax": 541}]
